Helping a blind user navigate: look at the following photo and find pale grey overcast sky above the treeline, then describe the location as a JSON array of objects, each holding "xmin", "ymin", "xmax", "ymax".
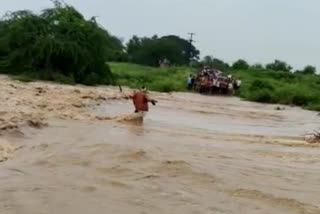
[{"xmin": 0, "ymin": 0, "xmax": 320, "ymax": 69}]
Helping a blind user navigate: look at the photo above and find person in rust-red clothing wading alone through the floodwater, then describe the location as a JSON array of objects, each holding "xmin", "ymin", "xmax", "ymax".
[{"xmin": 129, "ymin": 86, "xmax": 157, "ymax": 116}]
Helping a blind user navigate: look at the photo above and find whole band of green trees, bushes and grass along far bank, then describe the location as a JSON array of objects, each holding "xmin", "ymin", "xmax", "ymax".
[{"xmin": 0, "ymin": 0, "xmax": 320, "ymax": 110}]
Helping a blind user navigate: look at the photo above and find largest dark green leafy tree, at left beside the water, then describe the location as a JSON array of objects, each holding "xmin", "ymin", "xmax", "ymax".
[{"xmin": 0, "ymin": 1, "xmax": 123, "ymax": 84}]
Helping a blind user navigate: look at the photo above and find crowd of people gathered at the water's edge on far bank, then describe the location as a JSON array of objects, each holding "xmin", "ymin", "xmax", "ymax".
[{"xmin": 187, "ymin": 67, "xmax": 242, "ymax": 95}]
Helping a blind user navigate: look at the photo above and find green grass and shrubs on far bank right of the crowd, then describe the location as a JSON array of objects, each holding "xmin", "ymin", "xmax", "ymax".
[{"xmin": 230, "ymin": 70, "xmax": 320, "ymax": 111}]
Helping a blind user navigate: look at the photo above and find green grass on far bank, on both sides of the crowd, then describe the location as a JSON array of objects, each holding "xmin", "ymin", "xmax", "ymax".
[{"xmin": 109, "ymin": 63, "xmax": 320, "ymax": 111}]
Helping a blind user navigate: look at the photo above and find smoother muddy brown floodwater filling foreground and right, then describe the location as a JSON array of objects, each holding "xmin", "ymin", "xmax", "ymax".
[{"xmin": 0, "ymin": 93, "xmax": 320, "ymax": 214}]
